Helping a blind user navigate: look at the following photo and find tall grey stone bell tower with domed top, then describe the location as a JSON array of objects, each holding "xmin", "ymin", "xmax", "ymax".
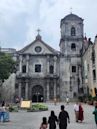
[{"xmin": 59, "ymin": 13, "xmax": 83, "ymax": 98}]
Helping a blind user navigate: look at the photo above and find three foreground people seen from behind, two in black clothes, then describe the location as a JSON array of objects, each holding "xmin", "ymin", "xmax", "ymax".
[{"xmin": 40, "ymin": 105, "xmax": 70, "ymax": 129}]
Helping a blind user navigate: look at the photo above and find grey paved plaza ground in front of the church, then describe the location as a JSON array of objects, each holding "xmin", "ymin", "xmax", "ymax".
[{"xmin": 0, "ymin": 103, "xmax": 96, "ymax": 129}]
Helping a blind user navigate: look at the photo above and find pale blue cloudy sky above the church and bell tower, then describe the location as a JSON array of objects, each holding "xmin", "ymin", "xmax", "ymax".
[{"xmin": 0, "ymin": 0, "xmax": 97, "ymax": 50}]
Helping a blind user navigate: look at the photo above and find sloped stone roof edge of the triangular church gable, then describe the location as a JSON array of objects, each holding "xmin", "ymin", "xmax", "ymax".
[{"xmin": 18, "ymin": 34, "xmax": 59, "ymax": 54}]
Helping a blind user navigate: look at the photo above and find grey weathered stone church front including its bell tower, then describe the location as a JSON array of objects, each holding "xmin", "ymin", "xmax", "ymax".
[{"xmin": 15, "ymin": 14, "xmax": 83, "ymax": 102}]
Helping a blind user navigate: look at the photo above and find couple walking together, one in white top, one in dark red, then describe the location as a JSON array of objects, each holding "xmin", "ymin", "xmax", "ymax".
[{"xmin": 74, "ymin": 102, "xmax": 84, "ymax": 122}]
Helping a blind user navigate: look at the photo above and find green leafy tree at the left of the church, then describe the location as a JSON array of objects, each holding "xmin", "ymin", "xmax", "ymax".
[{"xmin": 0, "ymin": 52, "xmax": 16, "ymax": 81}]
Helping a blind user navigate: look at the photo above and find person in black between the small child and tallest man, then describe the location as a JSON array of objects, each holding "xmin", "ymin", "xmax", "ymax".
[{"xmin": 48, "ymin": 111, "xmax": 58, "ymax": 129}]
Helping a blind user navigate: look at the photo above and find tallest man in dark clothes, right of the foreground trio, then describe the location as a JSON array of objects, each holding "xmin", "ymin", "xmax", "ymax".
[{"xmin": 59, "ymin": 105, "xmax": 70, "ymax": 129}]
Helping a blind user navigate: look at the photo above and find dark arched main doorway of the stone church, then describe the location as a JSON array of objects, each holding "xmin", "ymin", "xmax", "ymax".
[{"xmin": 32, "ymin": 85, "xmax": 44, "ymax": 102}]
